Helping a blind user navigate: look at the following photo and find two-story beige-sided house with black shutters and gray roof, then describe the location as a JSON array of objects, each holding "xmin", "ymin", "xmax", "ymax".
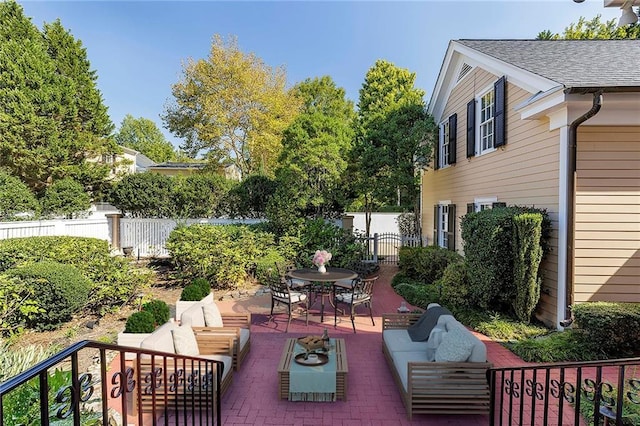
[{"xmin": 421, "ymin": 40, "xmax": 640, "ymax": 327}]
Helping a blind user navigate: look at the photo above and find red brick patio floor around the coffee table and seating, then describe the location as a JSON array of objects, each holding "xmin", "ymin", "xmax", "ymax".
[{"xmin": 208, "ymin": 266, "xmax": 526, "ymax": 426}]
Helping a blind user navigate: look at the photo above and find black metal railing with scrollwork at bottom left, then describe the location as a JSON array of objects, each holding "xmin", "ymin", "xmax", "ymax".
[{"xmin": 0, "ymin": 341, "xmax": 224, "ymax": 426}]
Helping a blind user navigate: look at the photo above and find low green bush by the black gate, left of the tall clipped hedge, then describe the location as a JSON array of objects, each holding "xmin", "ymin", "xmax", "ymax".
[{"xmin": 399, "ymin": 246, "xmax": 462, "ymax": 283}]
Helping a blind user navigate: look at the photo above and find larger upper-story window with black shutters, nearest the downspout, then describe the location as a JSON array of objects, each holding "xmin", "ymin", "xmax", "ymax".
[{"xmin": 467, "ymin": 77, "xmax": 507, "ymax": 158}]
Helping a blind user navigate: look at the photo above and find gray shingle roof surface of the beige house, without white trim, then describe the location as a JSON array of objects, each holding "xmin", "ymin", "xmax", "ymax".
[{"xmin": 456, "ymin": 40, "xmax": 640, "ymax": 88}]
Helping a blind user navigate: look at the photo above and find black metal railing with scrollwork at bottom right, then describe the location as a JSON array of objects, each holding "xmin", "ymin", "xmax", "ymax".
[{"xmin": 487, "ymin": 358, "xmax": 640, "ymax": 426}]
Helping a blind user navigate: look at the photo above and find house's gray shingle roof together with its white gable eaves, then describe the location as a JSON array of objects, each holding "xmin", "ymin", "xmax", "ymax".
[{"xmin": 429, "ymin": 40, "xmax": 640, "ymax": 121}]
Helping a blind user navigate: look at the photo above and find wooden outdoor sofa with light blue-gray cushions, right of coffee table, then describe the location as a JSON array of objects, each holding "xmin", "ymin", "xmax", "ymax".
[{"xmin": 382, "ymin": 303, "xmax": 491, "ymax": 420}]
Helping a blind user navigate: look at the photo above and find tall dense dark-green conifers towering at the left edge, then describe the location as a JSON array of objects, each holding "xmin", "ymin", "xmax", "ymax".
[{"xmin": 0, "ymin": 1, "xmax": 117, "ymax": 191}]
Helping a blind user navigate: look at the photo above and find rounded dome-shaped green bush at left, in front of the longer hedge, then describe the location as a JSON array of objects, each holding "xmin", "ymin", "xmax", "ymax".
[{"xmin": 8, "ymin": 261, "xmax": 92, "ymax": 330}]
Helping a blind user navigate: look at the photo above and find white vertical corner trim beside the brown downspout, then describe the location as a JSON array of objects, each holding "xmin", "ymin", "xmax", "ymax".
[{"xmin": 556, "ymin": 126, "xmax": 570, "ymax": 330}]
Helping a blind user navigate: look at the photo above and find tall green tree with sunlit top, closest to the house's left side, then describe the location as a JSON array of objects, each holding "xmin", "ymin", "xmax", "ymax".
[{"xmin": 352, "ymin": 60, "xmax": 435, "ymax": 232}]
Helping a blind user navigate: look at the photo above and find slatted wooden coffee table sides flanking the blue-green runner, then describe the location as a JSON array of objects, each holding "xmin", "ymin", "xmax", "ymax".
[{"xmin": 278, "ymin": 338, "xmax": 349, "ymax": 401}]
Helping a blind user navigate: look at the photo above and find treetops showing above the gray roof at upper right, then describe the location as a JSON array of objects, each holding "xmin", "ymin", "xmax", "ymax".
[{"xmin": 536, "ymin": 15, "xmax": 640, "ymax": 40}]
